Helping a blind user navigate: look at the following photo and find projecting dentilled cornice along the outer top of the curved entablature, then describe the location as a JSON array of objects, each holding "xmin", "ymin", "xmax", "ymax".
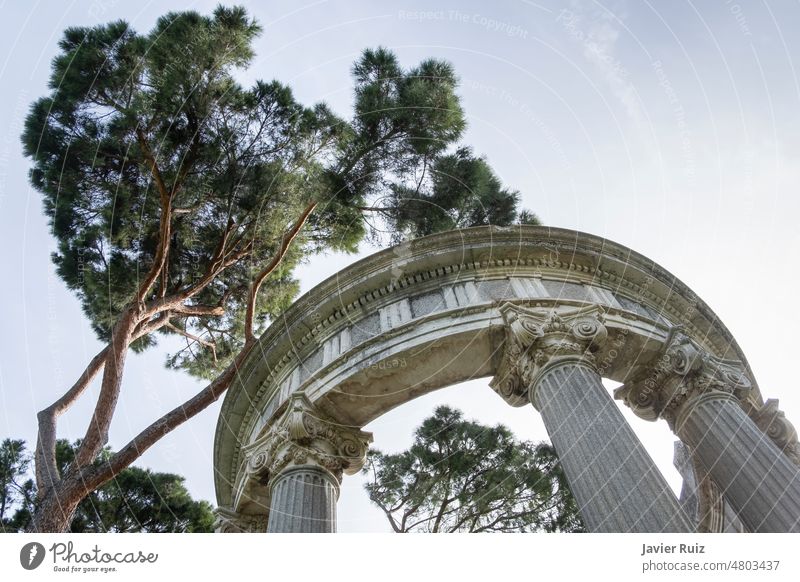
[{"xmin": 223, "ymin": 227, "xmax": 752, "ymax": 422}]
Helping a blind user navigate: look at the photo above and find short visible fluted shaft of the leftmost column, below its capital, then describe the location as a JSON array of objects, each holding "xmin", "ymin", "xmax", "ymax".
[{"xmin": 267, "ymin": 465, "xmax": 339, "ymax": 533}]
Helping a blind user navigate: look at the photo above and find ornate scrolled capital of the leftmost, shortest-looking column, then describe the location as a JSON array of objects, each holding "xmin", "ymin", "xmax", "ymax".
[{"xmin": 245, "ymin": 393, "xmax": 372, "ymax": 484}]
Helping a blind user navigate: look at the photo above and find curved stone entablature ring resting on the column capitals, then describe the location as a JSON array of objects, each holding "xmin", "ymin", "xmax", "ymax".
[{"xmin": 214, "ymin": 226, "xmax": 780, "ymax": 509}]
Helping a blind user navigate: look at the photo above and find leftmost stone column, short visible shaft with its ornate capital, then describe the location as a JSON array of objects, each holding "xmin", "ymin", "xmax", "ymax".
[{"xmin": 242, "ymin": 393, "xmax": 372, "ymax": 533}]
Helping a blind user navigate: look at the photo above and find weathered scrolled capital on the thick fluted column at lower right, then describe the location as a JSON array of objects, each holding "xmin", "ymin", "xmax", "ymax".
[{"xmin": 614, "ymin": 328, "xmax": 752, "ymax": 430}]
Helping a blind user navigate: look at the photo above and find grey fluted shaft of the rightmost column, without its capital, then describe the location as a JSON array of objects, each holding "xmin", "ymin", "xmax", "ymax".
[{"xmin": 675, "ymin": 391, "xmax": 800, "ymax": 532}]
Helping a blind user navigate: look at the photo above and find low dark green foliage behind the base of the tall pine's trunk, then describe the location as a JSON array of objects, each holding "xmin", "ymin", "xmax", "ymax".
[{"xmin": 0, "ymin": 439, "xmax": 214, "ymax": 533}]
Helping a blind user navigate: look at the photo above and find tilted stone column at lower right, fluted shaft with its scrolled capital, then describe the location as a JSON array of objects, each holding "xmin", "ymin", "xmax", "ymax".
[{"xmin": 619, "ymin": 334, "xmax": 800, "ymax": 532}]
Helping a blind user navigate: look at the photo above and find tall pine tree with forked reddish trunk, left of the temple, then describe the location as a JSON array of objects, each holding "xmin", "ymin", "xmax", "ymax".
[{"xmin": 22, "ymin": 7, "xmax": 530, "ymax": 529}]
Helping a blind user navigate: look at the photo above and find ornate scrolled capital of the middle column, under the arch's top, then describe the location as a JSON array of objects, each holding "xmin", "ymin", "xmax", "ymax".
[{"xmin": 491, "ymin": 303, "xmax": 608, "ymax": 406}]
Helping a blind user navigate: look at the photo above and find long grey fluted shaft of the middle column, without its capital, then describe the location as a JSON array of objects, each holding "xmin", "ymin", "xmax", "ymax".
[{"xmin": 530, "ymin": 361, "xmax": 692, "ymax": 532}]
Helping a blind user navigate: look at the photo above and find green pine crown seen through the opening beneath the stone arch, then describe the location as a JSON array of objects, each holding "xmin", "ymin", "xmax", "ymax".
[{"xmin": 363, "ymin": 406, "xmax": 584, "ymax": 533}]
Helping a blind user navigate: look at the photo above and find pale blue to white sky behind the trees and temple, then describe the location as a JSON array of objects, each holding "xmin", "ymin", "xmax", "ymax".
[{"xmin": 0, "ymin": 0, "xmax": 800, "ymax": 531}]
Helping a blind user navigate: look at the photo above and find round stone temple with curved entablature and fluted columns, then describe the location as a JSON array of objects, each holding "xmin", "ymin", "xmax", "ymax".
[{"xmin": 214, "ymin": 226, "xmax": 800, "ymax": 532}]
